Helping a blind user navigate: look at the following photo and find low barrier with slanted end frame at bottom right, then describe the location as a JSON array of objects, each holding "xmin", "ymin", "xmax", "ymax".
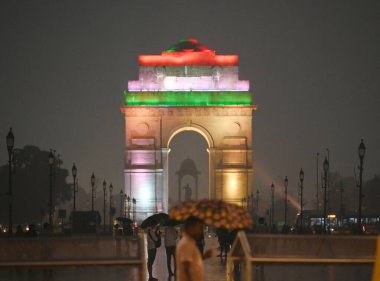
[{"xmin": 227, "ymin": 232, "xmax": 380, "ymax": 281}]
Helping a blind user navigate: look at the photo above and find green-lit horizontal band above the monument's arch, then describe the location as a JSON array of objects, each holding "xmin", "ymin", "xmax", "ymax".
[{"xmin": 124, "ymin": 91, "xmax": 252, "ymax": 106}]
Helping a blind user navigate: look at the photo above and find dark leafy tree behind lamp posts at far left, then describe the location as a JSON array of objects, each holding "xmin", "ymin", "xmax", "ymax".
[{"xmin": 0, "ymin": 145, "xmax": 71, "ymax": 224}]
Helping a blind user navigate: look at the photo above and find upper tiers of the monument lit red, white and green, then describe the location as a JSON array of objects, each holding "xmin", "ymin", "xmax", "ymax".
[{"xmin": 125, "ymin": 39, "xmax": 252, "ymax": 106}]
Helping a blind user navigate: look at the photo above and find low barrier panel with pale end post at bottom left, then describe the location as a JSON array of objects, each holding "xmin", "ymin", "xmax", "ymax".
[{"xmin": 0, "ymin": 234, "xmax": 146, "ymax": 281}]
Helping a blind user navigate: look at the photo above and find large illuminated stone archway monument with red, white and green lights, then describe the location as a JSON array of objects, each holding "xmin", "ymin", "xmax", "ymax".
[{"xmin": 121, "ymin": 39, "xmax": 256, "ymax": 220}]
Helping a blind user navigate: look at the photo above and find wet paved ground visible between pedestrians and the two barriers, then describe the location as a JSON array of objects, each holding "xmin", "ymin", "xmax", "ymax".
[{"xmin": 153, "ymin": 237, "xmax": 226, "ymax": 281}]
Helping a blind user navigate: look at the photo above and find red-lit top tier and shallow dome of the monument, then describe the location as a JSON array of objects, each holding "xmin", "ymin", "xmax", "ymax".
[{"xmin": 139, "ymin": 39, "xmax": 239, "ymax": 66}]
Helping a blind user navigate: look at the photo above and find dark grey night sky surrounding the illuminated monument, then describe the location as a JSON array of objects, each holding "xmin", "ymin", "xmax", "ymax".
[{"xmin": 0, "ymin": 0, "xmax": 380, "ymax": 210}]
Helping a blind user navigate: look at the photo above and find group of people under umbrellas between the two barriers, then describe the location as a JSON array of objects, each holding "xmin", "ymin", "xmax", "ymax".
[{"xmin": 146, "ymin": 217, "xmax": 237, "ymax": 281}]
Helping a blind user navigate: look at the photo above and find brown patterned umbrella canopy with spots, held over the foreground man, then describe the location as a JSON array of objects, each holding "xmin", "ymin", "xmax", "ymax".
[{"xmin": 169, "ymin": 199, "xmax": 253, "ymax": 229}]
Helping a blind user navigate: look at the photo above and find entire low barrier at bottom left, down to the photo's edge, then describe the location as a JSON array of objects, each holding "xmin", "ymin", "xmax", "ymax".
[{"xmin": 0, "ymin": 234, "xmax": 146, "ymax": 281}]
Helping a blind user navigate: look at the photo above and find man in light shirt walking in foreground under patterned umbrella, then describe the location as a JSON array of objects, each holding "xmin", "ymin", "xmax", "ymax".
[{"xmin": 176, "ymin": 217, "xmax": 212, "ymax": 281}]
